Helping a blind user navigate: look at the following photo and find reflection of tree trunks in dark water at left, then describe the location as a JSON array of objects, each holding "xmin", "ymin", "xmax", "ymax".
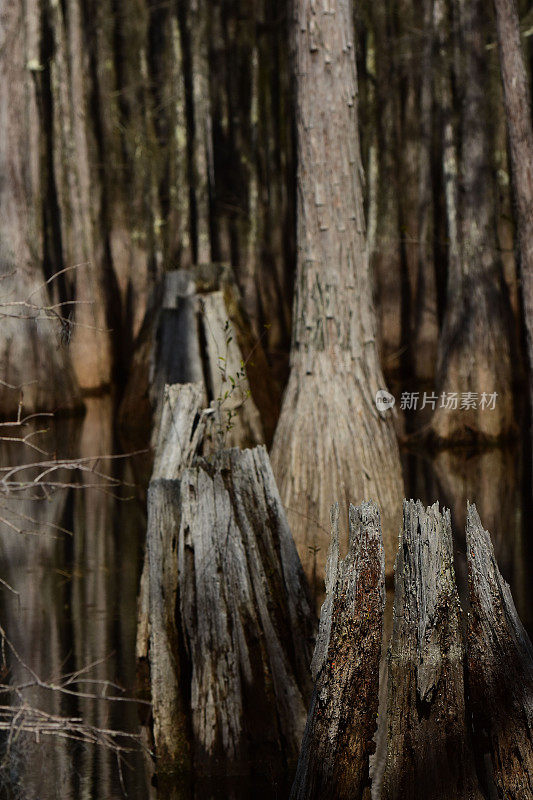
[{"xmin": 0, "ymin": 398, "xmax": 145, "ymax": 800}]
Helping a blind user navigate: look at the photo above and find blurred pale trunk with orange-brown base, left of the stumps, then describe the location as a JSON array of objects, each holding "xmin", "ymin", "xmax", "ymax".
[{"xmin": 44, "ymin": 0, "xmax": 113, "ymax": 390}]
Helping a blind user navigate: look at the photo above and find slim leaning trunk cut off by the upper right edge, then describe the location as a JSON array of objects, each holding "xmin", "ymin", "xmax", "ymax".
[{"xmin": 494, "ymin": 0, "xmax": 533, "ymax": 460}]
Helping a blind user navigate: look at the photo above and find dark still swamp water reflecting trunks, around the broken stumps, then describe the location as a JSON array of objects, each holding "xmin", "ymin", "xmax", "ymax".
[{"xmin": 0, "ymin": 398, "xmax": 533, "ymax": 800}]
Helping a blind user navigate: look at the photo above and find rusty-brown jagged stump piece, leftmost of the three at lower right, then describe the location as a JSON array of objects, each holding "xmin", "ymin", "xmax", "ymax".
[{"xmin": 291, "ymin": 503, "xmax": 385, "ymax": 800}]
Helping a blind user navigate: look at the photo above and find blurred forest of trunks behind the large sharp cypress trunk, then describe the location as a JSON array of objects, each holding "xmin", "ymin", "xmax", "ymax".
[{"xmin": 1, "ymin": 0, "xmax": 533, "ymax": 422}]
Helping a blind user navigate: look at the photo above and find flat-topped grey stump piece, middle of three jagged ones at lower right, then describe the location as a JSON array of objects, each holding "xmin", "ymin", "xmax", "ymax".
[{"xmin": 382, "ymin": 500, "xmax": 482, "ymax": 800}]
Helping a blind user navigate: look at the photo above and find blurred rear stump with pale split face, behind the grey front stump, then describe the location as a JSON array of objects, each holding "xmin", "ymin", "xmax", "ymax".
[{"xmin": 120, "ymin": 265, "xmax": 277, "ymax": 446}]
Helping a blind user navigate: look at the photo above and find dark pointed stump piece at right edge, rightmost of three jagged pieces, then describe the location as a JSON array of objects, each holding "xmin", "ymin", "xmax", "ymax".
[{"xmin": 466, "ymin": 504, "xmax": 533, "ymax": 800}]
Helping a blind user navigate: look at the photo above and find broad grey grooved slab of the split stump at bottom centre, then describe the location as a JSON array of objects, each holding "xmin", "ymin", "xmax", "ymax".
[{"xmin": 178, "ymin": 447, "xmax": 314, "ymax": 777}]
